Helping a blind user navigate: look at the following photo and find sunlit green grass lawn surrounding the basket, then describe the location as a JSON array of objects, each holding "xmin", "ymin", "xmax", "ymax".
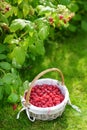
[{"xmin": 0, "ymin": 33, "xmax": 87, "ymax": 130}]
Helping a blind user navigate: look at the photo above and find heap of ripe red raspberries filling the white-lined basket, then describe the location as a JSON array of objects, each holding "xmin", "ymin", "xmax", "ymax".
[{"xmin": 25, "ymin": 84, "xmax": 64, "ymax": 108}]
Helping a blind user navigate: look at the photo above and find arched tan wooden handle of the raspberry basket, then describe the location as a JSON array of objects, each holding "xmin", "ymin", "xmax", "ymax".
[{"xmin": 26, "ymin": 68, "xmax": 64, "ymax": 105}]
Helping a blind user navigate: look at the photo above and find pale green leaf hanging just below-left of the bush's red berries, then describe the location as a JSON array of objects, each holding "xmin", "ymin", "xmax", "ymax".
[{"xmin": 38, "ymin": 25, "xmax": 49, "ymax": 40}]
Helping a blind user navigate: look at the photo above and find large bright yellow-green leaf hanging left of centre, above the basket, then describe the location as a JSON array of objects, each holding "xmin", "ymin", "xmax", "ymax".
[{"xmin": 10, "ymin": 47, "xmax": 26, "ymax": 65}]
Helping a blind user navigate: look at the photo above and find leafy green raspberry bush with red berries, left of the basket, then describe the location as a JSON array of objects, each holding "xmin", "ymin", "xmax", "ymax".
[{"xmin": 0, "ymin": 0, "xmax": 74, "ymax": 103}]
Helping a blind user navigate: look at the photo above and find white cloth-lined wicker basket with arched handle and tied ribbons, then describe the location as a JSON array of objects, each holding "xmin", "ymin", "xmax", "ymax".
[{"xmin": 17, "ymin": 68, "xmax": 79, "ymax": 121}]
